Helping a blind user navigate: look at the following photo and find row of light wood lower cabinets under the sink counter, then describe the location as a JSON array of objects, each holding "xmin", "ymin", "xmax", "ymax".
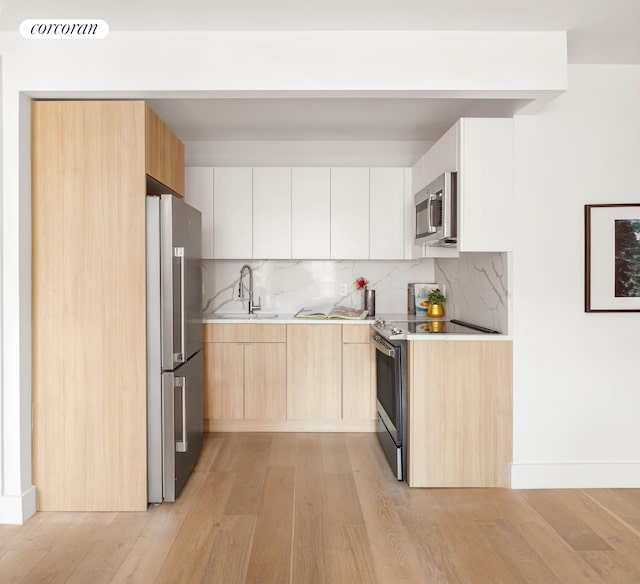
[{"xmin": 204, "ymin": 323, "xmax": 375, "ymax": 432}]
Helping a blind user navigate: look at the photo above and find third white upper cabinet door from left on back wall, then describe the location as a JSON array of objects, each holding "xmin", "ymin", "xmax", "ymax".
[{"xmin": 253, "ymin": 167, "xmax": 291, "ymax": 259}]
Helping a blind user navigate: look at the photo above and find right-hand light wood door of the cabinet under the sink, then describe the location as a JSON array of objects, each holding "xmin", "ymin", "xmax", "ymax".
[{"xmin": 244, "ymin": 343, "xmax": 287, "ymax": 420}]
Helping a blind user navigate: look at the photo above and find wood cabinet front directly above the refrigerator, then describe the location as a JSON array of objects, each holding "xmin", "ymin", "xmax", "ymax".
[{"xmin": 146, "ymin": 102, "xmax": 184, "ymax": 197}]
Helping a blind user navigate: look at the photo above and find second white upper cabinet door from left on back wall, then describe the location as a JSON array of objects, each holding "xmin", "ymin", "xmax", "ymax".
[{"xmin": 213, "ymin": 167, "xmax": 253, "ymax": 259}]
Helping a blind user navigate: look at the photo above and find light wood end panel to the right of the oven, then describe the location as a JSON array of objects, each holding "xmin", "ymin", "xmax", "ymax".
[{"xmin": 408, "ymin": 341, "xmax": 512, "ymax": 487}]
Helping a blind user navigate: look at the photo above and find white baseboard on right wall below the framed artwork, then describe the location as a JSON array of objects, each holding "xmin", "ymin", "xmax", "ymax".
[{"xmin": 511, "ymin": 462, "xmax": 640, "ymax": 489}]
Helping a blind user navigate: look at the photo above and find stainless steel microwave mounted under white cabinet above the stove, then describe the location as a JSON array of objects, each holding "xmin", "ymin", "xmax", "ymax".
[{"xmin": 415, "ymin": 172, "xmax": 458, "ymax": 247}]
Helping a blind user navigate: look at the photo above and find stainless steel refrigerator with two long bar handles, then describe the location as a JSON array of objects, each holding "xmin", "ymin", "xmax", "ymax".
[{"xmin": 146, "ymin": 195, "xmax": 203, "ymax": 503}]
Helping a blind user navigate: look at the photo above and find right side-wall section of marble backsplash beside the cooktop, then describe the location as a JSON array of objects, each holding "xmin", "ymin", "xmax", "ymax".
[{"xmin": 435, "ymin": 253, "xmax": 511, "ymax": 333}]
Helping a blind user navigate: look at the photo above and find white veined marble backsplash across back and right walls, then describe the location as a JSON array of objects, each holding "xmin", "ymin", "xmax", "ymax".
[{"xmin": 202, "ymin": 253, "xmax": 511, "ymax": 332}]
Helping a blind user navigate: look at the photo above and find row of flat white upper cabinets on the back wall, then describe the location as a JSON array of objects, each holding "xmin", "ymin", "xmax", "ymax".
[{"xmin": 185, "ymin": 167, "xmax": 411, "ymax": 259}]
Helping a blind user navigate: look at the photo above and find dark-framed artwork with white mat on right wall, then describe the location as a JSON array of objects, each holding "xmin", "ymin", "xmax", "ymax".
[{"xmin": 584, "ymin": 203, "xmax": 640, "ymax": 312}]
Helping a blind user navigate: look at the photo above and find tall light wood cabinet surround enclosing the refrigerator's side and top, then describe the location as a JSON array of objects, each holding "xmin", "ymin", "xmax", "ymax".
[{"xmin": 31, "ymin": 101, "xmax": 184, "ymax": 511}]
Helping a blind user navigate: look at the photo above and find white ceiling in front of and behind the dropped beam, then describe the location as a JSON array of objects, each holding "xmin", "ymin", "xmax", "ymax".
[{"xmin": 0, "ymin": 0, "xmax": 640, "ymax": 141}]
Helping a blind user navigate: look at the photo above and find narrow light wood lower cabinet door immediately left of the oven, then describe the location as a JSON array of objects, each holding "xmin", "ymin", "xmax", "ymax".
[{"xmin": 342, "ymin": 344, "xmax": 376, "ymax": 420}]
